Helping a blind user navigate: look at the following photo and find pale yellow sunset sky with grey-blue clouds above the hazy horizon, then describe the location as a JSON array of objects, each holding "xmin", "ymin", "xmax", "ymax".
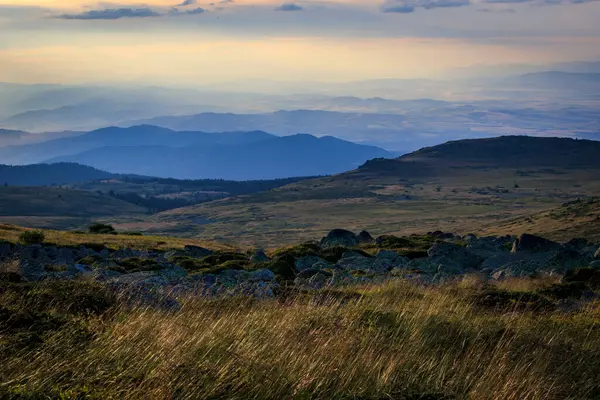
[{"xmin": 0, "ymin": 0, "xmax": 600, "ymax": 85}]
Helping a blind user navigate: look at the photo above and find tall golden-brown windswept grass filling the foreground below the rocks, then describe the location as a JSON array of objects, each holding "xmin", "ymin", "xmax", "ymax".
[{"xmin": 0, "ymin": 279, "xmax": 600, "ymax": 400}]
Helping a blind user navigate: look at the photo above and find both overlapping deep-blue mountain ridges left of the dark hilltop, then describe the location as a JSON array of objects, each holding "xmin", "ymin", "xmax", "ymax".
[{"xmin": 0, "ymin": 125, "xmax": 394, "ymax": 183}]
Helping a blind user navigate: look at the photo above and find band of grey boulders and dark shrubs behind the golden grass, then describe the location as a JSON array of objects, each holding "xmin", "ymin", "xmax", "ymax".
[{"xmin": 0, "ymin": 229, "xmax": 600, "ymax": 309}]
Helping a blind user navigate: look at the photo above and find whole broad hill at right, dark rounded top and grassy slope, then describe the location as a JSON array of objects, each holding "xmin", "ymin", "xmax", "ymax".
[{"xmin": 132, "ymin": 137, "xmax": 600, "ymax": 247}]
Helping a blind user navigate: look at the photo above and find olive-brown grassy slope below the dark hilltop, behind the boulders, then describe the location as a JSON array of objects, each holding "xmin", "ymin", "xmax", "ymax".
[{"xmin": 129, "ymin": 169, "xmax": 600, "ymax": 247}]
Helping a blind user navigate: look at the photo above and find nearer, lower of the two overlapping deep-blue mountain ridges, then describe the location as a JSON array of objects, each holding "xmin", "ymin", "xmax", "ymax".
[{"xmin": 48, "ymin": 132, "xmax": 393, "ymax": 180}]
